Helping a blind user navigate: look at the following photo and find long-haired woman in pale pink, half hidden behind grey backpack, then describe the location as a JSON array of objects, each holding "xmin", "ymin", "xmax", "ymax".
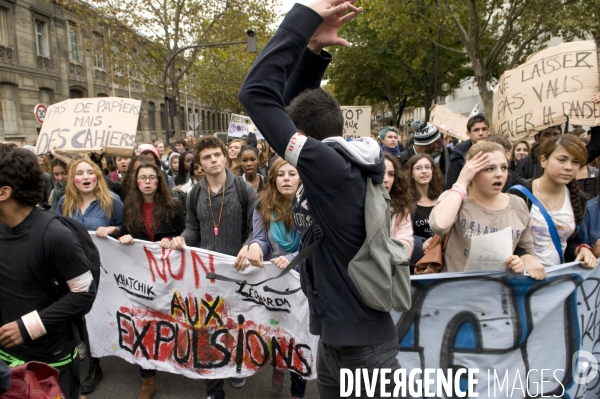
[{"xmin": 383, "ymin": 152, "xmax": 415, "ymax": 258}]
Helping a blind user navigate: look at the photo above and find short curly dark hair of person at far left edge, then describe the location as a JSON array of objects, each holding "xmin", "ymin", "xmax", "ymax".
[{"xmin": 0, "ymin": 148, "xmax": 46, "ymax": 206}]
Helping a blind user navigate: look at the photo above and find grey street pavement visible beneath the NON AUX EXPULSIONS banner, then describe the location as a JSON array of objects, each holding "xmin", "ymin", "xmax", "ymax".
[{"xmin": 81, "ymin": 356, "xmax": 319, "ymax": 399}]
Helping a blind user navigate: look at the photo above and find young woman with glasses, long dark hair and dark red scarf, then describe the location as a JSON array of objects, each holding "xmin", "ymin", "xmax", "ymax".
[{"xmin": 119, "ymin": 161, "xmax": 185, "ymax": 399}]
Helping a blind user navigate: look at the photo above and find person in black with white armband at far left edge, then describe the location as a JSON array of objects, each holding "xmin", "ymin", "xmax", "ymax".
[{"xmin": 0, "ymin": 149, "xmax": 96, "ymax": 398}]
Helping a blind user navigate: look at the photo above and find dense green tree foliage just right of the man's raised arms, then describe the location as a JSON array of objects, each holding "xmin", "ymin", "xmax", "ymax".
[{"xmin": 328, "ymin": 0, "xmax": 472, "ymax": 125}]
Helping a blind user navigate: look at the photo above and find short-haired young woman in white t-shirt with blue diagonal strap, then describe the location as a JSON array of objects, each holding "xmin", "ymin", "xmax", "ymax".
[{"xmin": 511, "ymin": 134, "xmax": 598, "ymax": 268}]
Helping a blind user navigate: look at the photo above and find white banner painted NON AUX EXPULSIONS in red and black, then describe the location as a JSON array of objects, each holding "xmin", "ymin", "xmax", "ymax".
[{"xmin": 86, "ymin": 236, "xmax": 318, "ymax": 379}]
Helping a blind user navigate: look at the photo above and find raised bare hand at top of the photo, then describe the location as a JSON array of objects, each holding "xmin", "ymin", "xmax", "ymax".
[{"xmin": 308, "ymin": 0, "xmax": 362, "ymax": 54}]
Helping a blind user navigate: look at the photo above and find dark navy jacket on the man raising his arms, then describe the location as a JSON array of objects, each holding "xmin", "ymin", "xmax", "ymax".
[{"xmin": 239, "ymin": 4, "xmax": 397, "ymax": 346}]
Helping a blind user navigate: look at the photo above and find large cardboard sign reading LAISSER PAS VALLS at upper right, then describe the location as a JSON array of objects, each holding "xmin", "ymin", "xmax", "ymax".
[{"xmin": 493, "ymin": 41, "xmax": 600, "ymax": 139}]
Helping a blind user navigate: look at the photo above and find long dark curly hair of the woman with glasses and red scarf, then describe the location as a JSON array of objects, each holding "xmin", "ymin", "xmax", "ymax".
[{"xmin": 123, "ymin": 160, "xmax": 175, "ymax": 235}]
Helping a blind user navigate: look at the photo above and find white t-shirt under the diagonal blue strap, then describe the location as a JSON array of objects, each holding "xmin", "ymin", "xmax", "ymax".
[{"xmin": 529, "ymin": 186, "xmax": 576, "ymax": 267}]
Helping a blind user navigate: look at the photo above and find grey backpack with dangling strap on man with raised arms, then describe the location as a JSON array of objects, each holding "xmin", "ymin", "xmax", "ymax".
[{"xmin": 206, "ymin": 177, "xmax": 411, "ymax": 312}]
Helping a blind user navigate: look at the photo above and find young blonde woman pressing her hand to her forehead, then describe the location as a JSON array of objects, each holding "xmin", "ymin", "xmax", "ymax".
[{"xmin": 429, "ymin": 141, "xmax": 546, "ymax": 280}]
